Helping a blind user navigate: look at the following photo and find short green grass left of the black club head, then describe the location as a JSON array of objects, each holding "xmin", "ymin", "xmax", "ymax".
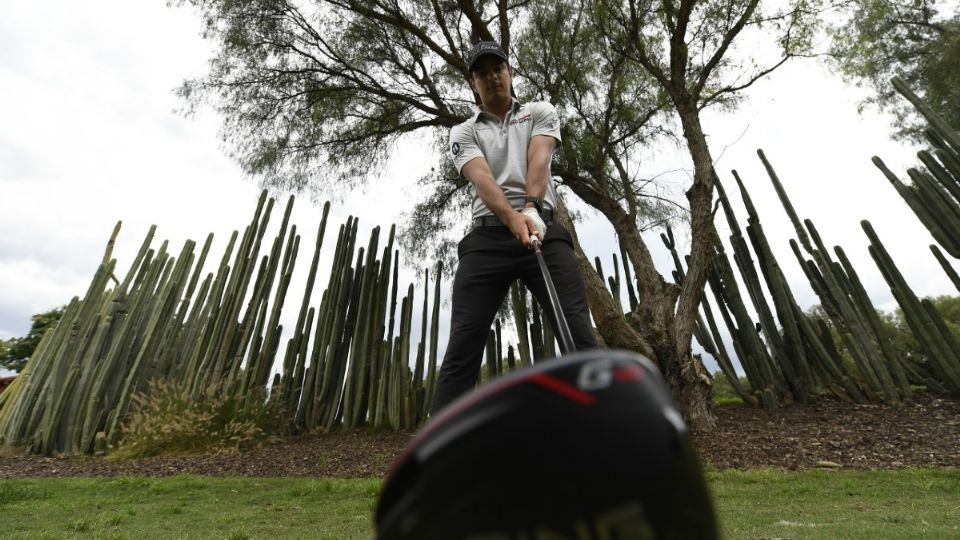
[{"xmin": 0, "ymin": 476, "xmax": 380, "ymax": 540}]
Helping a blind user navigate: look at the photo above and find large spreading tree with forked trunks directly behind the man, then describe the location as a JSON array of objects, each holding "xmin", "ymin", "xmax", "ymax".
[{"xmin": 181, "ymin": 0, "xmax": 813, "ymax": 427}]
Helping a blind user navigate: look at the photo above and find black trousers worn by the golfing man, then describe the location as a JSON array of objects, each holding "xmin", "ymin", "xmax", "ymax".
[{"xmin": 433, "ymin": 223, "xmax": 597, "ymax": 412}]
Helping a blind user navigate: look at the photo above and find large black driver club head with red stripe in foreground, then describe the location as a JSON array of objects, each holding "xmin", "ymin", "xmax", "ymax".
[{"xmin": 375, "ymin": 350, "xmax": 717, "ymax": 540}]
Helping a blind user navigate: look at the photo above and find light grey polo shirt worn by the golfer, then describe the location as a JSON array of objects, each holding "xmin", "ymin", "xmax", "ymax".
[{"xmin": 449, "ymin": 100, "xmax": 560, "ymax": 218}]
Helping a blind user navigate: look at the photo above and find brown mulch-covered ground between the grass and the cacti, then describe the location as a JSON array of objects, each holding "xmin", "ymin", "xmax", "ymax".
[{"xmin": 0, "ymin": 395, "xmax": 960, "ymax": 478}]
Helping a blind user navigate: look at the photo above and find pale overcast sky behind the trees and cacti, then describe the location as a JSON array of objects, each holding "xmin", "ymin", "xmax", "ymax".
[{"xmin": 0, "ymin": 0, "xmax": 956, "ymax": 380}]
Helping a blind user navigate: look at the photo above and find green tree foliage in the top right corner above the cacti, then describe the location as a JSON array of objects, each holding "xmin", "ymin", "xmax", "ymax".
[{"xmin": 830, "ymin": 0, "xmax": 960, "ymax": 139}]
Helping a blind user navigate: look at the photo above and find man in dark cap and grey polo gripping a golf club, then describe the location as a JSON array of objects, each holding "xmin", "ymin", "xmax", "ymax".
[{"xmin": 433, "ymin": 41, "xmax": 597, "ymax": 412}]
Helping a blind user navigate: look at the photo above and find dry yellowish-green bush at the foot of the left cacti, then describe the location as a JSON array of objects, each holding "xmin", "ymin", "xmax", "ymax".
[{"xmin": 112, "ymin": 379, "xmax": 283, "ymax": 458}]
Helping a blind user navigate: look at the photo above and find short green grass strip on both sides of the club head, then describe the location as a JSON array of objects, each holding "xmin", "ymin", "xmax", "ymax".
[{"xmin": 0, "ymin": 469, "xmax": 960, "ymax": 540}]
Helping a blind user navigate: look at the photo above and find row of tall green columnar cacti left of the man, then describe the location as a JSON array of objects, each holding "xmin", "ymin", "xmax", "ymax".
[{"xmin": 0, "ymin": 192, "xmax": 458, "ymax": 454}]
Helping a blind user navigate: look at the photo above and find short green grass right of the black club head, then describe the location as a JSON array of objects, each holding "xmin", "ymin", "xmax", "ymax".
[{"xmin": 708, "ymin": 469, "xmax": 960, "ymax": 540}]
